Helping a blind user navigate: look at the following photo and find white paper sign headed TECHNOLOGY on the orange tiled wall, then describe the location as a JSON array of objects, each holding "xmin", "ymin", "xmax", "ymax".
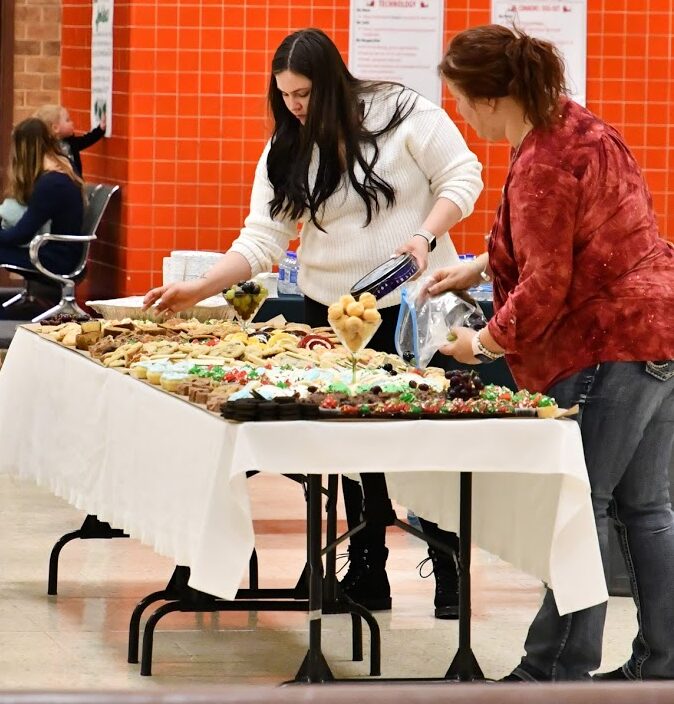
[{"xmin": 349, "ymin": 0, "xmax": 444, "ymax": 105}]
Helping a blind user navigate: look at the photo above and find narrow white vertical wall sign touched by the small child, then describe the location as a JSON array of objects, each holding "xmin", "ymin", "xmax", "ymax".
[{"xmin": 91, "ymin": 0, "xmax": 114, "ymax": 137}]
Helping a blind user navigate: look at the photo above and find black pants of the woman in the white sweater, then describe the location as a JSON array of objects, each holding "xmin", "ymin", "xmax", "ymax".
[{"xmin": 304, "ymin": 297, "xmax": 457, "ymax": 550}]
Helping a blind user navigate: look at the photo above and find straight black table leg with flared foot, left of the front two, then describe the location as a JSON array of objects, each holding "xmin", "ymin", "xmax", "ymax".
[{"xmin": 295, "ymin": 474, "xmax": 334, "ymax": 683}]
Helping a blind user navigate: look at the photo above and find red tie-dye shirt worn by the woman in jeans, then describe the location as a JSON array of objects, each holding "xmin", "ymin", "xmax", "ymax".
[{"xmin": 489, "ymin": 100, "xmax": 674, "ymax": 391}]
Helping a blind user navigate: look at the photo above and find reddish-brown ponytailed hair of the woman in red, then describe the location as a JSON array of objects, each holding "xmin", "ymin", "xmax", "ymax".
[{"xmin": 438, "ymin": 24, "xmax": 566, "ymax": 128}]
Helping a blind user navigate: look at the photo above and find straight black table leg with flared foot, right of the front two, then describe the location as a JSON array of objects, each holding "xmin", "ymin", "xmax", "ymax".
[{"xmin": 445, "ymin": 472, "xmax": 484, "ymax": 682}]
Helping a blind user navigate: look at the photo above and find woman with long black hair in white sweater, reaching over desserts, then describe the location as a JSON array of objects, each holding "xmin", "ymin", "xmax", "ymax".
[{"xmin": 145, "ymin": 29, "xmax": 482, "ymax": 618}]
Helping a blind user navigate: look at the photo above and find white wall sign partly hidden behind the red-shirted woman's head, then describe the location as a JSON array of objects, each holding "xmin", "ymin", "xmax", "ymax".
[{"xmin": 491, "ymin": 0, "xmax": 587, "ymax": 105}]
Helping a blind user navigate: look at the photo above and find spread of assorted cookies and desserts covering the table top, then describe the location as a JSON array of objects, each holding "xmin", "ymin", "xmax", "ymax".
[{"xmin": 26, "ymin": 282, "xmax": 575, "ymax": 422}]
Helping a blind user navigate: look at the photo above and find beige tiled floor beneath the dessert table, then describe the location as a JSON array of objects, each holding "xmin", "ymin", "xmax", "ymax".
[{"xmin": 0, "ymin": 476, "xmax": 635, "ymax": 689}]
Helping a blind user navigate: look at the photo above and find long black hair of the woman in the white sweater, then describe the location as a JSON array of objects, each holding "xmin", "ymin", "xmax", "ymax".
[{"xmin": 267, "ymin": 29, "xmax": 416, "ymax": 230}]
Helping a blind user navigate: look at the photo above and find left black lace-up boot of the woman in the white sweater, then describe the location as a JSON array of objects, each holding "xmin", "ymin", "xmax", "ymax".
[{"xmin": 339, "ymin": 545, "xmax": 391, "ymax": 611}]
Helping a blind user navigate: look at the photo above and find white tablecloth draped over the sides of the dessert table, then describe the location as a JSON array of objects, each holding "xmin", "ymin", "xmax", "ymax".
[{"xmin": 0, "ymin": 329, "xmax": 608, "ymax": 613}]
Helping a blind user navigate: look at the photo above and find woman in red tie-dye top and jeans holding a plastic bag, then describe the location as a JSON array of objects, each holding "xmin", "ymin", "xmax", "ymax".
[{"xmin": 431, "ymin": 25, "xmax": 674, "ymax": 681}]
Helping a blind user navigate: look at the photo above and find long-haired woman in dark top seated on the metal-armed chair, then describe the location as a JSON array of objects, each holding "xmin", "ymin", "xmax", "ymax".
[{"xmin": 0, "ymin": 117, "xmax": 84, "ymax": 274}]
